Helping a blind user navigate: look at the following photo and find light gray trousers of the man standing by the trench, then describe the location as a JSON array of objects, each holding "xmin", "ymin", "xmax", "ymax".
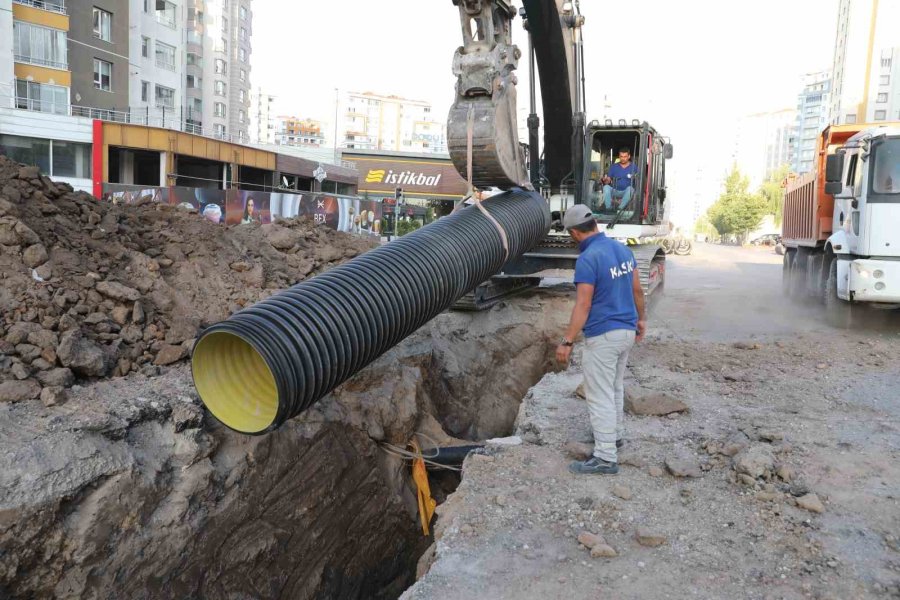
[{"xmin": 581, "ymin": 329, "xmax": 635, "ymax": 462}]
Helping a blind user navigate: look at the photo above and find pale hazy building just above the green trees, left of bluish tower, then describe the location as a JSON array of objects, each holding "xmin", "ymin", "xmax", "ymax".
[{"xmin": 734, "ymin": 108, "xmax": 797, "ymax": 188}]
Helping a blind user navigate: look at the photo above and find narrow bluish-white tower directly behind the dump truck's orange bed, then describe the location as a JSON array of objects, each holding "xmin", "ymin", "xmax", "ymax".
[{"xmin": 791, "ymin": 71, "xmax": 832, "ymax": 174}]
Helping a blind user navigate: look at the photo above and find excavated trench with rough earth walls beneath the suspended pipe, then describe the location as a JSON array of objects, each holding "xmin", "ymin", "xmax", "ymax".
[{"xmin": 0, "ymin": 290, "xmax": 569, "ymax": 600}]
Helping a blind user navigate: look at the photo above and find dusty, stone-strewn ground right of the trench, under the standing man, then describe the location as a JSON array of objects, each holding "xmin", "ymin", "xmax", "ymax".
[{"xmin": 402, "ymin": 247, "xmax": 900, "ymax": 600}]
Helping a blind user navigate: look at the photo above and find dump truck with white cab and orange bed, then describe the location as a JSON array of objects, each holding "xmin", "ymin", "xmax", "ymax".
[{"xmin": 782, "ymin": 122, "xmax": 900, "ymax": 327}]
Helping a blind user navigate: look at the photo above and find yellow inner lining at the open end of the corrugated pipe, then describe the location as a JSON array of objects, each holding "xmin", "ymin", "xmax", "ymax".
[{"xmin": 191, "ymin": 331, "xmax": 278, "ymax": 433}]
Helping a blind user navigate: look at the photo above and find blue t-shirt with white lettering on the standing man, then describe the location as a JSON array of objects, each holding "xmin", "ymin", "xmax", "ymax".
[{"xmin": 575, "ymin": 233, "xmax": 638, "ymax": 337}]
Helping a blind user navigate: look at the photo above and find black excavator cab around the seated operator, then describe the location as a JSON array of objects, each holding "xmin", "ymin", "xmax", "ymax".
[{"xmin": 583, "ymin": 121, "xmax": 672, "ymax": 225}]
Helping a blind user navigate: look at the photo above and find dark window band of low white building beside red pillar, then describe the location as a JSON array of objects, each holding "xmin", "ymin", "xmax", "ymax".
[{"xmin": 0, "ymin": 135, "xmax": 91, "ymax": 179}]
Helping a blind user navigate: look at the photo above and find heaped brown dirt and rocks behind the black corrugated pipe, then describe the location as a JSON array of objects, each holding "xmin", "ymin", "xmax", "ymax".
[{"xmin": 0, "ymin": 157, "xmax": 375, "ymax": 405}]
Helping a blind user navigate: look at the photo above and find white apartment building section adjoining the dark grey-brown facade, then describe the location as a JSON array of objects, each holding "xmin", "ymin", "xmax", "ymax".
[{"xmin": 128, "ymin": 0, "xmax": 185, "ymax": 124}]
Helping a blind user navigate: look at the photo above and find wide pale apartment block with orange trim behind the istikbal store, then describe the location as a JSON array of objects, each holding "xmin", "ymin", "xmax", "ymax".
[{"xmin": 341, "ymin": 92, "xmax": 447, "ymax": 153}]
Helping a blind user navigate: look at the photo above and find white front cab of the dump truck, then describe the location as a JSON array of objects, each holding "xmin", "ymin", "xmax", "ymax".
[{"xmin": 825, "ymin": 127, "xmax": 900, "ymax": 308}]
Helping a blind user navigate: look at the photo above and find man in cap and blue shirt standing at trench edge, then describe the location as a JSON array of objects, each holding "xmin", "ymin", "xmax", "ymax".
[{"xmin": 556, "ymin": 204, "xmax": 647, "ymax": 475}]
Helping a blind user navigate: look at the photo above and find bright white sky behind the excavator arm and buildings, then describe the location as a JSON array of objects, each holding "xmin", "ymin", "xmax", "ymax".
[{"xmin": 251, "ymin": 0, "xmax": 838, "ymax": 224}]
